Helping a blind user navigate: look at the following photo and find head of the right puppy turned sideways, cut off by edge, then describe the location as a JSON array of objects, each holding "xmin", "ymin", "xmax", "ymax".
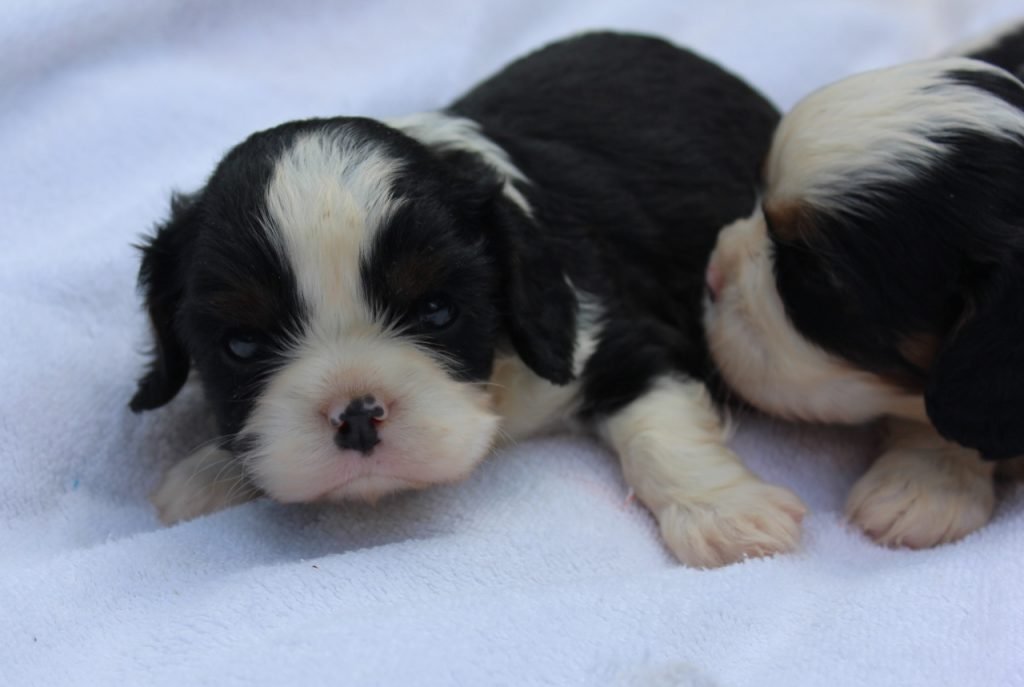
[{"xmin": 706, "ymin": 58, "xmax": 1024, "ymax": 457}]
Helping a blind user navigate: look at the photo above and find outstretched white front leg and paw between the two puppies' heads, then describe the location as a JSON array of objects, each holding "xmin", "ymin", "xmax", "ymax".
[{"xmin": 599, "ymin": 378, "xmax": 806, "ymax": 567}]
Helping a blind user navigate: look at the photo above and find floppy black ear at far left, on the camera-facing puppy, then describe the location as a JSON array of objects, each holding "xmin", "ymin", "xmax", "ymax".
[{"xmin": 129, "ymin": 194, "xmax": 197, "ymax": 413}]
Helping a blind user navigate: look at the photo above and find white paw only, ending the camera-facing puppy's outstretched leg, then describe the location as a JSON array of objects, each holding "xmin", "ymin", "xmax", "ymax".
[{"xmin": 655, "ymin": 477, "xmax": 807, "ymax": 568}]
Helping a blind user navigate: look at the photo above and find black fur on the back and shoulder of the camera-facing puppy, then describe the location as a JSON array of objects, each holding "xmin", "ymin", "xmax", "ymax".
[{"xmin": 452, "ymin": 34, "xmax": 778, "ymax": 415}]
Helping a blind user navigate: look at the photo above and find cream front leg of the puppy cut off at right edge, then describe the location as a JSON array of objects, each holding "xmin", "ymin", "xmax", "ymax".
[{"xmin": 846, "ymin": 420, "xmax": 995, "ymax": 549}]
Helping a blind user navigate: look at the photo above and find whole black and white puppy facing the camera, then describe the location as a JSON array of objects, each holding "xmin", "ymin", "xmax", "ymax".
[{"xmin": 131, "ymin": 34, "xmax": 786, "ymax": 566}]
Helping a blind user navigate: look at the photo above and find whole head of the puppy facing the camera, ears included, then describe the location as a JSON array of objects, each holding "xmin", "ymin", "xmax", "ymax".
[{"xmin": 132, "ymin": 119, "xmax": 575, "ymax": 502}]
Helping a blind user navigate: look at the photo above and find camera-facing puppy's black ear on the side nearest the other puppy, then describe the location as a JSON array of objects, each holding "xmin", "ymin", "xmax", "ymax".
[{"xmin": 490, "ymin": 197, "xmax": 578, "ymax": 384}]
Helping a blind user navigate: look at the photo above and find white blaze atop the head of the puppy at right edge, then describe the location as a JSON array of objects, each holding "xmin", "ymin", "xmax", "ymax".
[{"xmin": 765, "ymin": 57, "xmax": 1024, "ymax": 208}]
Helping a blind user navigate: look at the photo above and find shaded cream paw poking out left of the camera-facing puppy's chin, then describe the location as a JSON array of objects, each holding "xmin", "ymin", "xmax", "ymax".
[{"xmin": 150, "ymin": 445, "xmax": 259, "ymax": 525}]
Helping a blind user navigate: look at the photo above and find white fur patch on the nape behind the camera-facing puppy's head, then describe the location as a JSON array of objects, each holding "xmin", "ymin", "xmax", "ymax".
[{"xmin": 385, "ymin": 112, "xmax": 530, "ymax": 215}]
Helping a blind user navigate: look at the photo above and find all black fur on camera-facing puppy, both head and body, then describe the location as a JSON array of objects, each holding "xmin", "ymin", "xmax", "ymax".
[{"xmin": 132, "ymin": 34, "xmax": 778, "ymax": 440}]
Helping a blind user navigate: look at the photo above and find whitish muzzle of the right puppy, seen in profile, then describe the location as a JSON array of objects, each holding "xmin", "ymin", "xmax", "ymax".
[{"xmin": 705, "ymin": 209, "xmax": 925, "ymax": 423}]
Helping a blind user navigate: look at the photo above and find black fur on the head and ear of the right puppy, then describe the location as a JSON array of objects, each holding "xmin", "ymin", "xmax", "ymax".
[{"xmin": 769, "ymin": 71, "xmax": 1024, "ymax": 459}]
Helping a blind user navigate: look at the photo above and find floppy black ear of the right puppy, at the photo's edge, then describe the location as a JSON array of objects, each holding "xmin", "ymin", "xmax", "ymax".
[{"xmin": 925, "ymin": 264, "xmax": 1024, "ymax": 460}]
